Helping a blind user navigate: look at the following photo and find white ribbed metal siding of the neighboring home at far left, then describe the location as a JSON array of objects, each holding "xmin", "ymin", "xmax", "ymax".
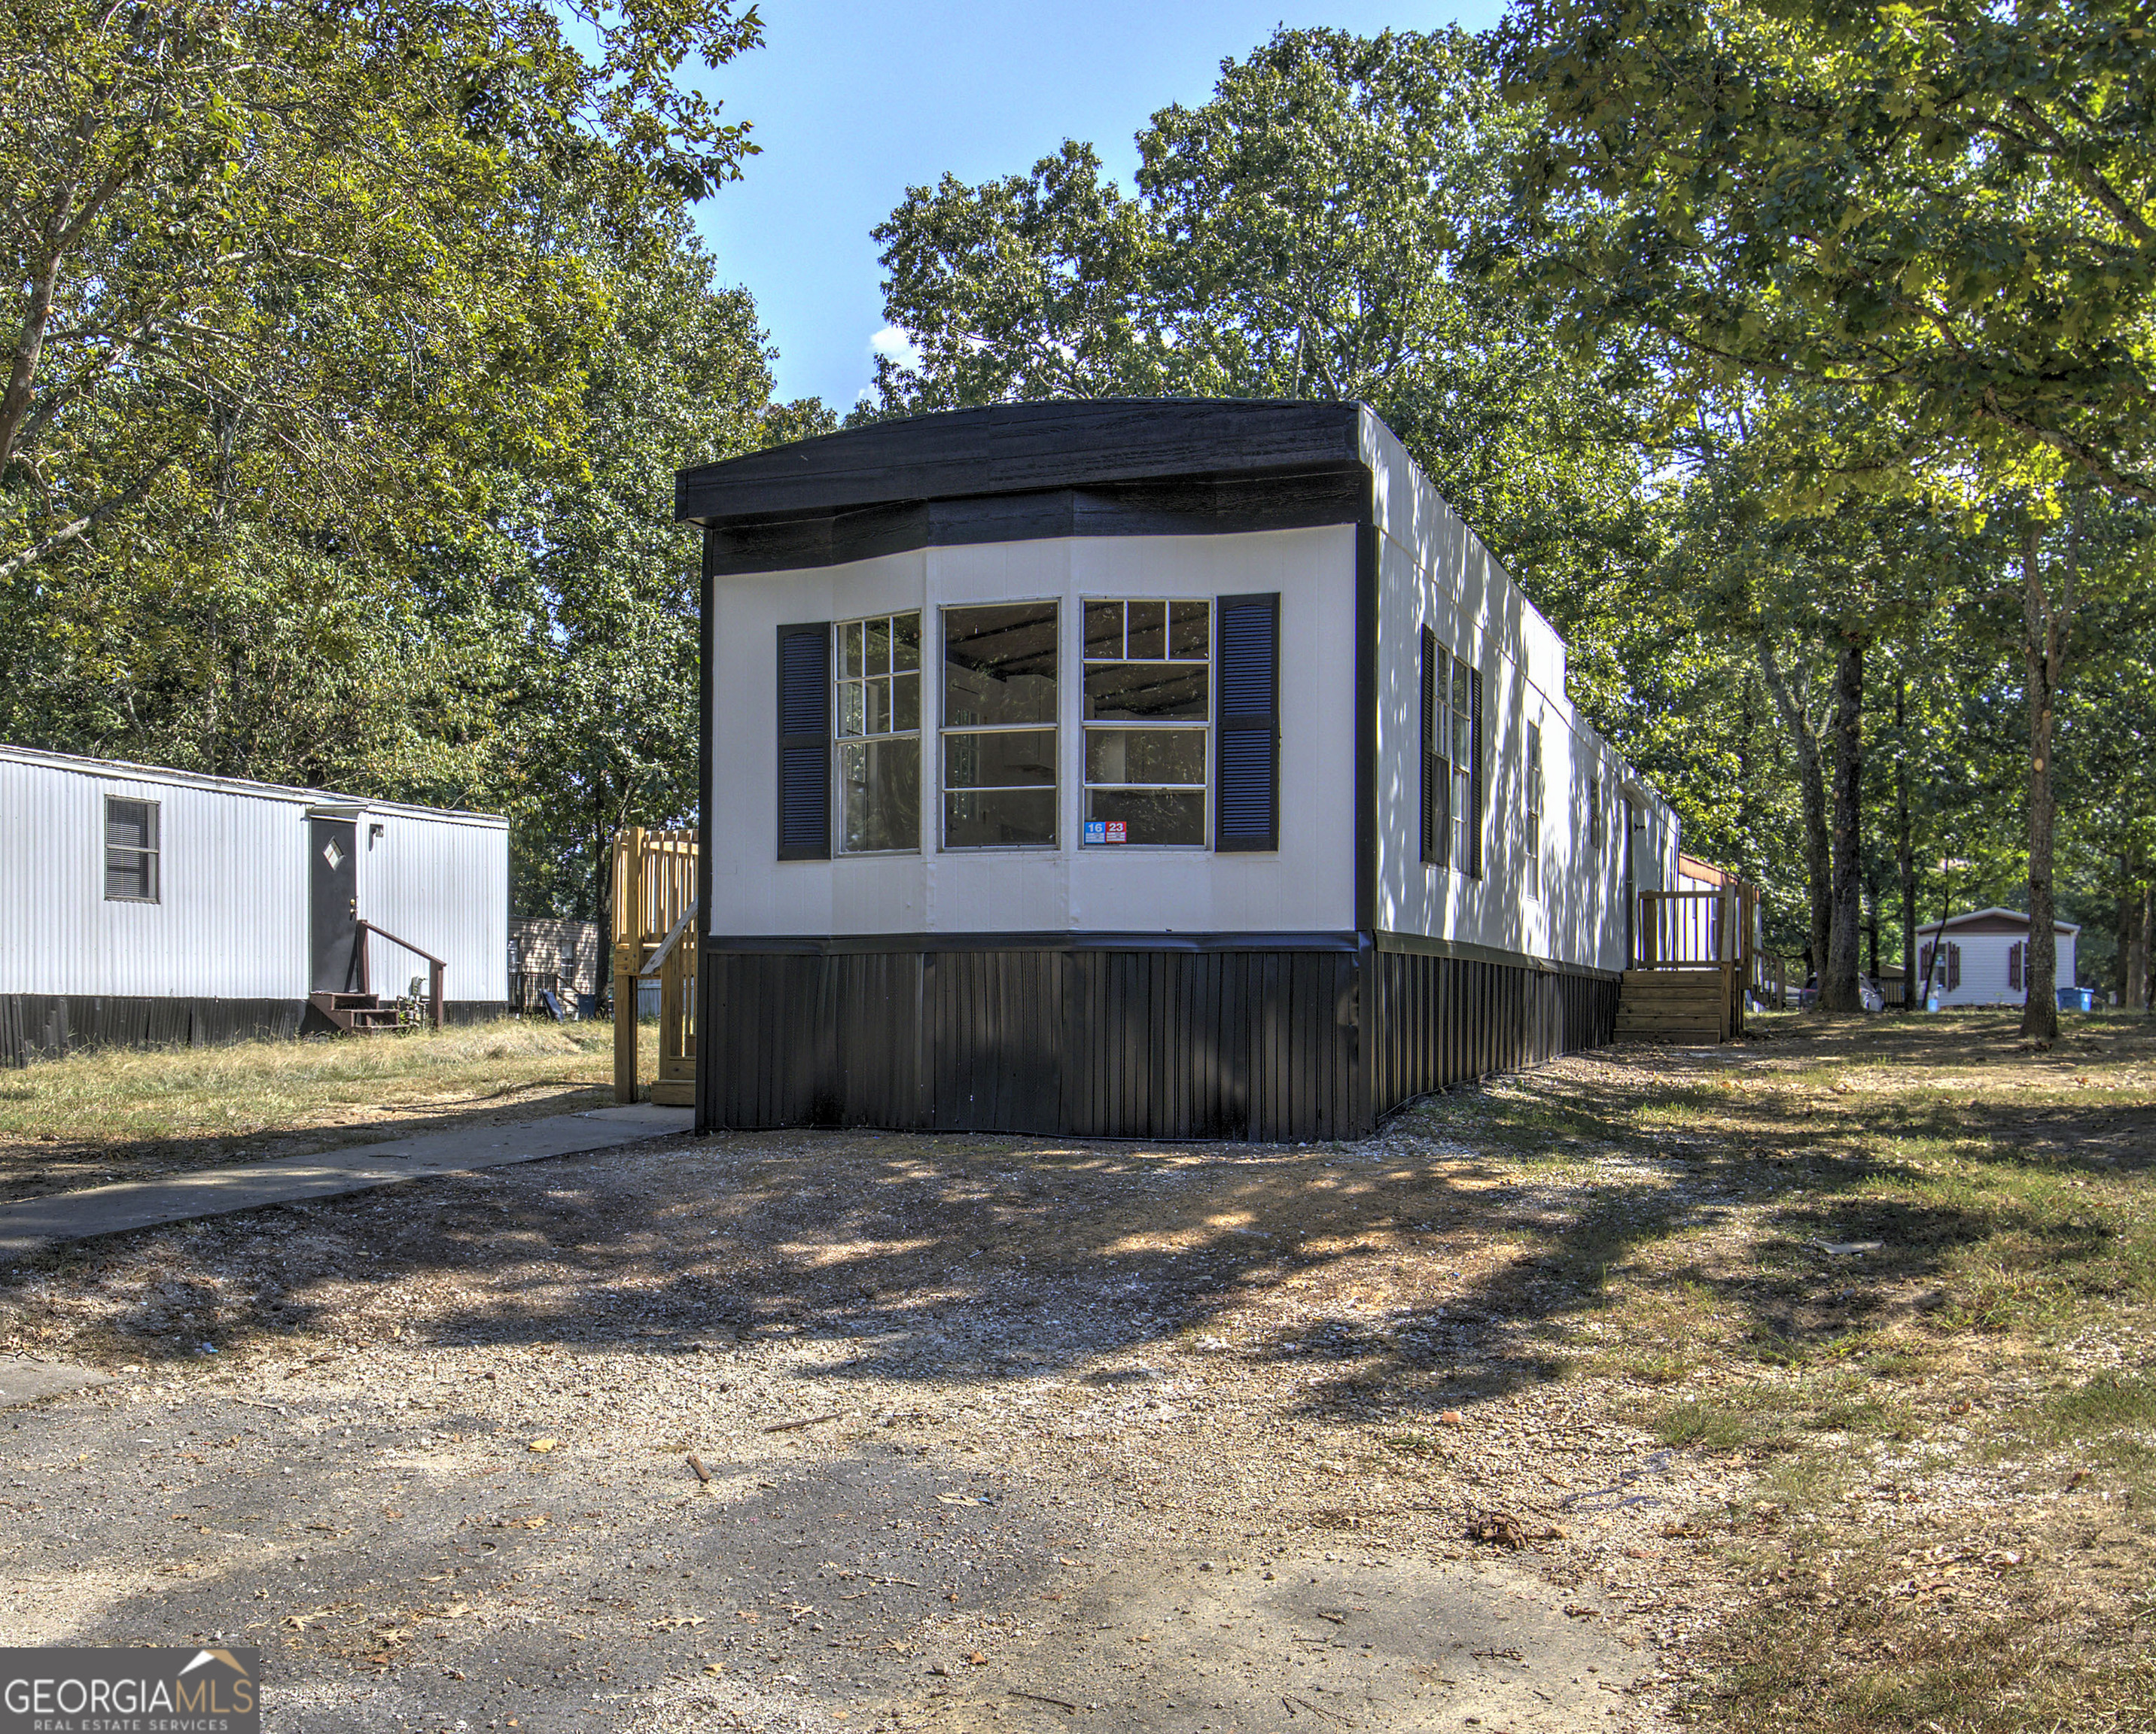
[{"xmin": 0, "ymin": 748, "xmax": 509, "ymax": 1003}]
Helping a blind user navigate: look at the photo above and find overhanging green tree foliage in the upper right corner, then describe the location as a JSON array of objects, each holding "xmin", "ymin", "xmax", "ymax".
[{"xmin": 1503, "ymin": 0, "xmax": 2156, "ymax": 500}]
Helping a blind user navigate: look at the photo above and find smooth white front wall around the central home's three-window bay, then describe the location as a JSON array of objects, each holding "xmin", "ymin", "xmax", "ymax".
[{"xmin": 711, "ymin": 526, "xmax": 1354, "ymax": 936}]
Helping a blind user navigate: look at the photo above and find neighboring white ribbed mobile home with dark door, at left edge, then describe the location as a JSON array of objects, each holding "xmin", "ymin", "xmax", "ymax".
[{"xmin": 0, "ymin": 747, "xmax": 509, "ymax": 1066}]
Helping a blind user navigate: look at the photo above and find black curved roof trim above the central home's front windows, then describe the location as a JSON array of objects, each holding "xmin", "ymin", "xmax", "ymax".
[{"xmin": 675, "ymin": 399, "xmax": 1369, "ymax": 541}]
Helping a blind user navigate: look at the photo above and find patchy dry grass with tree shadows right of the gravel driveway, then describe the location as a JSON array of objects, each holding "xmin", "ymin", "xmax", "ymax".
[{"xmin": 1421, "ymin": 1014, "xmax": 2156, "ymax": 1734}]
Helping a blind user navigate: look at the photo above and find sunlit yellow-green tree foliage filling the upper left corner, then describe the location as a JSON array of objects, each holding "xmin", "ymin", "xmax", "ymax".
[{"xmin": 0, "ymin": 0, "xmax": 757, "ymax": 580}]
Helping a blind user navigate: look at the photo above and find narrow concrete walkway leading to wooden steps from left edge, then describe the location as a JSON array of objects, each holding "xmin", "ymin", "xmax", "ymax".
[{"xmin": 0, "ymin": 1102, "xmax": 696, "ymax": 1264}]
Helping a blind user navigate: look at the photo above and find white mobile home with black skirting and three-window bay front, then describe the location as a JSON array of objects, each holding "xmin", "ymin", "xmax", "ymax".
[{"xmin": 677, "ymin": 401, "xmax": 1677, "ymax": 1139}]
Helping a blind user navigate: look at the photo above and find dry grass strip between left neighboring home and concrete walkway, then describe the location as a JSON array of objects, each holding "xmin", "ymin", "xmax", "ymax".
[{"xmin": 0, "ymin": 1018, "xmax": 658, "ymax": 1199}]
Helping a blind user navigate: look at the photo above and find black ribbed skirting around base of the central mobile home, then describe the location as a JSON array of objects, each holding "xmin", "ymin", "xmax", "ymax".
[{"xmin": 696, "ymin": 936, "xmax": 1617, "ymax": 1143}]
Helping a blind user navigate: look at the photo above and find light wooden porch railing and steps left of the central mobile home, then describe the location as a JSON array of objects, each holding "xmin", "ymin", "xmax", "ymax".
[{"xmin": 612, "ymin": 826, "xmax": 699, "ymax": 1106}]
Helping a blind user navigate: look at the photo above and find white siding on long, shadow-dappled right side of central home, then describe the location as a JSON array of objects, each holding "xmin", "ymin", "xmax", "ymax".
[{"xmin": 1363, "ymin": 414, "xmax": 1677, "ymax": 971}]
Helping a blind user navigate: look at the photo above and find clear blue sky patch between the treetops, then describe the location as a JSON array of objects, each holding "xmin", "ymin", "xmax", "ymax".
[{"xmin": 701, "ymin": 0, "xmax": 1500, "ymax": 409}]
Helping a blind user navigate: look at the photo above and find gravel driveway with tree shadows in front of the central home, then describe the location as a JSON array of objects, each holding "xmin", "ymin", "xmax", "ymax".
[{"xmin": 0, "ymin": 1121, "xmax": 1719, "ymax": 1732}]
